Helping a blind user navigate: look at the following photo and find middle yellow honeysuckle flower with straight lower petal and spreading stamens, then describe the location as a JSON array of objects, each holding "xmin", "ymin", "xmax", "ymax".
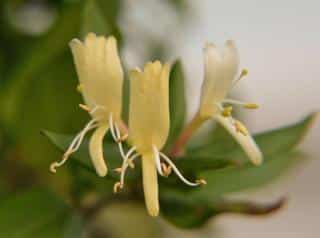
[{"xmin": 114, "ymin": 61, "xmax": 203, "ymax": 216}]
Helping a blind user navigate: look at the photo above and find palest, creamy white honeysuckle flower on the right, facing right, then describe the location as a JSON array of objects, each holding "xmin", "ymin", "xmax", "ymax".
[{"xmin": 199, "ymin": 41, "xmax": 263, "ymax": 165}]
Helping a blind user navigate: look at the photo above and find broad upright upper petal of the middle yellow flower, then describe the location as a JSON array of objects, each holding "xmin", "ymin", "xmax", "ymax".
[{"xmin": 129, "ymin": 62, "xmax": 170, "ymax": 153}]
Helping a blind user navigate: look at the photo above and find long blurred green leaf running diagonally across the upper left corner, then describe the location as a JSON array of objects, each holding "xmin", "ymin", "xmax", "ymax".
[{"xmin": 0, "ymin": 3, "xmax": 82, "ymax": 125}]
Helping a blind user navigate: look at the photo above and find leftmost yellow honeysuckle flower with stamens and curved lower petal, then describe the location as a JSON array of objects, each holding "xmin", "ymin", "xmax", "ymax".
[{"xmin": 50, "ymin": 33, "xmax": 123, "ymax": 176}]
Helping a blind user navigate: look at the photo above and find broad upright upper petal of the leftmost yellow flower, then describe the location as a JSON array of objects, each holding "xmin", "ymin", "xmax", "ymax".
[{"xmin": 70, "ymin": 33, "xmax": 123, "ymax": 122}]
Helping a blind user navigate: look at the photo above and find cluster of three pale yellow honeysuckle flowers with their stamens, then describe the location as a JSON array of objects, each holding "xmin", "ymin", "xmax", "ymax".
[{"xmin": 50, "ymin": 33, "xmax": 262, "ymax": 216}]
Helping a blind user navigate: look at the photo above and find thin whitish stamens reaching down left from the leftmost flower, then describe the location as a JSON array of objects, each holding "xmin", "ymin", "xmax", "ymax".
[{"xmin": 50, "ymin": 119, "xmax": 97, "ymax": 173}]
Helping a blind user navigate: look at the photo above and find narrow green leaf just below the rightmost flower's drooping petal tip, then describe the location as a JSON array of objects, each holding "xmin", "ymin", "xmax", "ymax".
[{"xmin": 192, "ymin": 153, "xmax": 303, "ymax": 199}]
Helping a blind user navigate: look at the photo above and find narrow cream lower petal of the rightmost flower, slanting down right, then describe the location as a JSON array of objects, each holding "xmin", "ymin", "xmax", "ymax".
[{"xmin": 214, "ymin": 115, "xmax": 263, "ymax": 165}]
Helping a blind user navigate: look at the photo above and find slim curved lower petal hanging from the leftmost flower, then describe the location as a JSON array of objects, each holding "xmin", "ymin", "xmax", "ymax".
[{"xmin": 89, "ymin": 124, "xmax": 109, "ymax": 177}]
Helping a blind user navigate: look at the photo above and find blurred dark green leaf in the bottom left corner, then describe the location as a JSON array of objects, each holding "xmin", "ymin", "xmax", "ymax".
[{"xmin": 0, "ymin": 189, "xmax": 83, "ymax": 238}]
